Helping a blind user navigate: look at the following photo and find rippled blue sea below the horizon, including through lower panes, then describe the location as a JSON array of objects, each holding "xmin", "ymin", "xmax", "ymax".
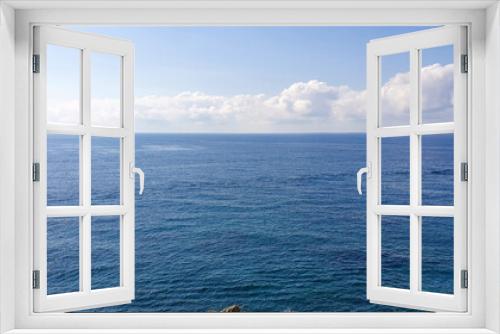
[{"xmin": 48, "ymin": 134, "xmax": 453, "ymax": 312}]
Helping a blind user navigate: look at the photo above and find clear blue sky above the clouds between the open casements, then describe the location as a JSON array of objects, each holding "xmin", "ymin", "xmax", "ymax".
[{"xmin": 75, "ymin": 27, "xmax": 434, "ymax": 96}]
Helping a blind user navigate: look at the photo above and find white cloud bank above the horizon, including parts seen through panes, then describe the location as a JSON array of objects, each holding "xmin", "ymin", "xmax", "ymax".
[{"xmin": 49, "ymin": 64, "xmax": 453, "ymax": 132}]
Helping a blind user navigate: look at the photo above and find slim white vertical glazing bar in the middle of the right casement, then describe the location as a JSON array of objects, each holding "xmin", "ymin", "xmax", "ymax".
[{"xmin": 410, "ymin": 49, "xmax": 421, "ymax": 292}]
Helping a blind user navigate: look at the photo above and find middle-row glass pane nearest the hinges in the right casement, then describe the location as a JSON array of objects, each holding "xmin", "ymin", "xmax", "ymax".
[{"xmin": 422, "ymin": 134, "xmax": 454, "ymax": 206}]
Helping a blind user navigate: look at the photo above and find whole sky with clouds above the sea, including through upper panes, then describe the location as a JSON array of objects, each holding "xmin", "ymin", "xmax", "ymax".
[{"xmin": 48, "ymin": 27, "xmax": 452, "ymax": 133}]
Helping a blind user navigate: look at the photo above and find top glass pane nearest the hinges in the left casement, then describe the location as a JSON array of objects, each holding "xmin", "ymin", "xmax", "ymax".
[{"xmin": 47, "ymin": 44, "xmax": 81, "ymax": 124}]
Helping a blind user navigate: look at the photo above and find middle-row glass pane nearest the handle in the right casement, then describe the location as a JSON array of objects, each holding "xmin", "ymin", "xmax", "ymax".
[{"xmin": 380, "ymin": 137, "xmax": 410, "ymax": 205}]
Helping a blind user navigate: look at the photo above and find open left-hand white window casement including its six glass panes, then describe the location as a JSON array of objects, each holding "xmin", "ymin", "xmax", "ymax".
[{"xmin": 33, "ymin": 27, "xmax": 142, "ymax": 312}]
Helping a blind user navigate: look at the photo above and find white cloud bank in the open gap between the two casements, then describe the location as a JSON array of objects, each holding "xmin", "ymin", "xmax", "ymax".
[{"xmin": 131, "ymin": 80, "xmax": 365, "ymax": 132}]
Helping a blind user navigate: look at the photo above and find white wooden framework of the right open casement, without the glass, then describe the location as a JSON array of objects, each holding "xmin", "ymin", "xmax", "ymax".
[{"xmin": 367, "ymin": 26, "xmax": 468, "ymax": 312}]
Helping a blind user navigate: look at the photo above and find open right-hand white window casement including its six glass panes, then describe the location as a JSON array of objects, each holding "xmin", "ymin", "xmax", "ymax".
[{"xmin": 359, "ymin": 26, "xmax": 468, "ymax": 312}]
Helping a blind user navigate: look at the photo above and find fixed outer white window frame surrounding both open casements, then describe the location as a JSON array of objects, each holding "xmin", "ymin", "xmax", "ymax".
[{"xmin": 0, "ymin": 0, "xmax": 500, "ymax": 333}]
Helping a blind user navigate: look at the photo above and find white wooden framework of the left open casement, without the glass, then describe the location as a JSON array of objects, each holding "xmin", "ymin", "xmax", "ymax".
[{"xmin": 33, "ymin": 27, "xmax": 135, "ymax": 312}]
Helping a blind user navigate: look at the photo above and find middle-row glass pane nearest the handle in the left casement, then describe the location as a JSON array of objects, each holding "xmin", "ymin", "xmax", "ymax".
[{"xmin": 92, "ymin": 137, "xmax": 121, "ymax": 205}]
